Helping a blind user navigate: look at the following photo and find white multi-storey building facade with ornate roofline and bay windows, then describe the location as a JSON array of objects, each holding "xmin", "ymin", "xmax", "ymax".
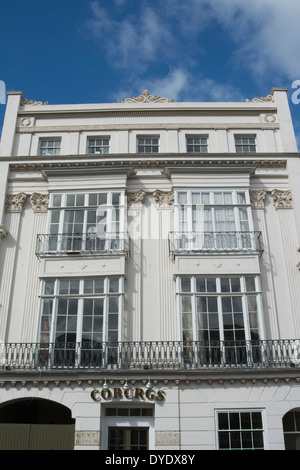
[{"xmin": 0, "ymin": 88, "xmax": 300, "ymax": 452}]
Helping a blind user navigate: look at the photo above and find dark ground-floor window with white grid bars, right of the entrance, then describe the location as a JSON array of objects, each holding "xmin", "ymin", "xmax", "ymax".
[{"xmin": 217, "ymin": 410, "xmax": 264, "ymax": 450}]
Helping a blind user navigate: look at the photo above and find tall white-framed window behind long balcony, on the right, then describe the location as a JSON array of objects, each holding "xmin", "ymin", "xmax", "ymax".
[{"xmin": 177, "ymin": 275, "xmax": 261, "ymax": 365}]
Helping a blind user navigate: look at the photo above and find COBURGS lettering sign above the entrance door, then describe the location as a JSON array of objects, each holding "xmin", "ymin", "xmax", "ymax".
[{"xmin": 91, "ymin": 388, "xmax": 166, "ymax": 401}]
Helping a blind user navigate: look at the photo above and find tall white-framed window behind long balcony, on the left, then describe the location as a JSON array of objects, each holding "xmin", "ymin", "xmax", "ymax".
[{"xmin": 39, "ymin": 277, "xmax": 124, "ymax": 367}]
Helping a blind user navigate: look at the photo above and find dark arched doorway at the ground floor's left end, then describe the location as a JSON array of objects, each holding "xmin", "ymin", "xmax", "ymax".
[{"xmin": 0, "ymin": 398, "xmax": 75, "ymax": 450}]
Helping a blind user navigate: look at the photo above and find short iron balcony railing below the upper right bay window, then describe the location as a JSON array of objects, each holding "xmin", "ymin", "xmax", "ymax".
[{"xmin": 169, "ymin": 231, "xmax": 263, "ymax": 256}]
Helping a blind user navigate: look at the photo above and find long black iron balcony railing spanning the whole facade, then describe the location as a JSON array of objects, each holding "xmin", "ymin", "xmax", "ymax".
[{"xmin": 0, "ymin": 340, "xmax": 300, "ymax": 371}]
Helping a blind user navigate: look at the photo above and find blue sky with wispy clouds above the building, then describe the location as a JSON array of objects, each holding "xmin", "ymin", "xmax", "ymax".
[{"xmin": 0, "ymin": 0, "xmax": 300, "ymax": 148}]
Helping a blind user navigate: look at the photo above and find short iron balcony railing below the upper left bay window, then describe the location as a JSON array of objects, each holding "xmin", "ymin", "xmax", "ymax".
[{"xmin": 36, "ymin": 232, "xmax": 129, "ymax": 256}]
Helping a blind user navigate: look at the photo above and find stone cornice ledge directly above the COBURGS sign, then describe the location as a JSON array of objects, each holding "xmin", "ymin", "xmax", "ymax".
[{"xmin": 0, "ymin": 368, "xmax": 300, "ymax": 389}]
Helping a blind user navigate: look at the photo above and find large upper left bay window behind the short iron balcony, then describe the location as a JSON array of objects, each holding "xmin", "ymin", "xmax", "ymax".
[{"xmin": 44, "ymin": 191, "xmax": 125, "ymax": 253}]
